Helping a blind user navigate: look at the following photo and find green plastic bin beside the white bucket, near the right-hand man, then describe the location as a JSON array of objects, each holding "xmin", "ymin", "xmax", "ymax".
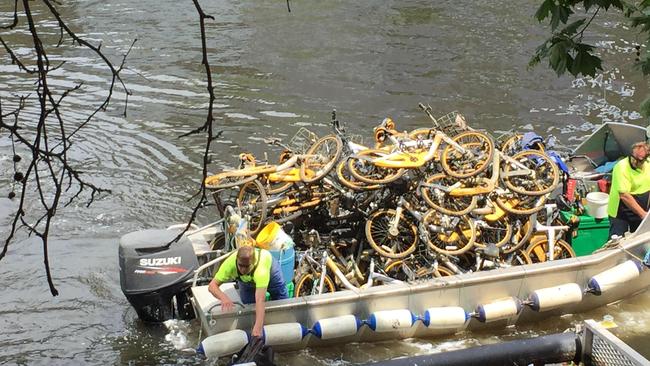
[{"xmin": 560, "ymin": 211, "xmax": 609, "ymax": 257}]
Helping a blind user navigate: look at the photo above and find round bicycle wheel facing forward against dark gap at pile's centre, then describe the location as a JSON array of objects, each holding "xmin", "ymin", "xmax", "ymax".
[{"xmin": 366, "ymin": 209, "xmax": 418, "ymax": 259}]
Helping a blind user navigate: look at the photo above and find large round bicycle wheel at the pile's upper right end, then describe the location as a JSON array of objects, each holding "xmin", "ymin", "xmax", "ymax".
[{"xmin": 503, "ymin": 150, "xmax": 560, "ymax": 196}]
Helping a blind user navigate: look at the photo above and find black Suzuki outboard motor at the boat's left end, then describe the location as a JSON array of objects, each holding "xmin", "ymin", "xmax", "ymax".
[{"xmin": 119, "ymin": 230, "xmax": 199, "ymax": 322}]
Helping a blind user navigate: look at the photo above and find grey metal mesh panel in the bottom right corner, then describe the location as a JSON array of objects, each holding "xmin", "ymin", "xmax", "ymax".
[{"xmin": 582, "ymin": 320, "xmax": 648, "ymax": 365}]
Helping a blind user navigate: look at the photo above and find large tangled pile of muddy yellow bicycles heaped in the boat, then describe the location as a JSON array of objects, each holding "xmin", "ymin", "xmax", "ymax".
[{"xmin": 205, "ymin": 104, "xmax": 575, "ymax": 296}]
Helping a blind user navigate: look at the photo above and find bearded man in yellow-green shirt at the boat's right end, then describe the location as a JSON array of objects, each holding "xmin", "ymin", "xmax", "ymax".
[{"xmin": 607, "ymin": 142, "xmax": 650, "ymax": 238}]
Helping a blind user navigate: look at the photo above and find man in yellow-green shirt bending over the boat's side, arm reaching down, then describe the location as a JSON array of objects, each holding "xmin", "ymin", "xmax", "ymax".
[{"xmin": 208, "ymin": 245, "xmax": 289, "ymax": 337}]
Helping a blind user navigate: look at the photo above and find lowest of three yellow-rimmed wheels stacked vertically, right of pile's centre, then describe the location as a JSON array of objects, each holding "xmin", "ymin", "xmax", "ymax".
[{"xmin": 423, "ymin": 210, "xmax": 476, "ymax": 255}]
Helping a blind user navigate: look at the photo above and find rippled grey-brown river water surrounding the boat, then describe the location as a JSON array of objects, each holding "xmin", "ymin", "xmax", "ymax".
[{"xmin": 0, "ymin": 0, "xmax": 650, "ymax": 365}]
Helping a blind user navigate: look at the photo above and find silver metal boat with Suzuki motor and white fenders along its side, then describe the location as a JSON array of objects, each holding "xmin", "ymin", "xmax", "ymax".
[{"xmin": 120, "ymin": 122, "xmax": 650, "ymax": 357}]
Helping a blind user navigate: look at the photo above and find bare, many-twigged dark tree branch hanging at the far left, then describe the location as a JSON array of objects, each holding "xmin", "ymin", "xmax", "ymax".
[{"xmin": 0, "ymin": 0, "xmax": 135, "ymax": 296}]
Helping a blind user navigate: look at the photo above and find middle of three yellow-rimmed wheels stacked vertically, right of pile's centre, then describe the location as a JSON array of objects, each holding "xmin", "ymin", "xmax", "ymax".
[{"xmin": 421, "ymin": 173, "xmax": 478, "ymax": 216}]
